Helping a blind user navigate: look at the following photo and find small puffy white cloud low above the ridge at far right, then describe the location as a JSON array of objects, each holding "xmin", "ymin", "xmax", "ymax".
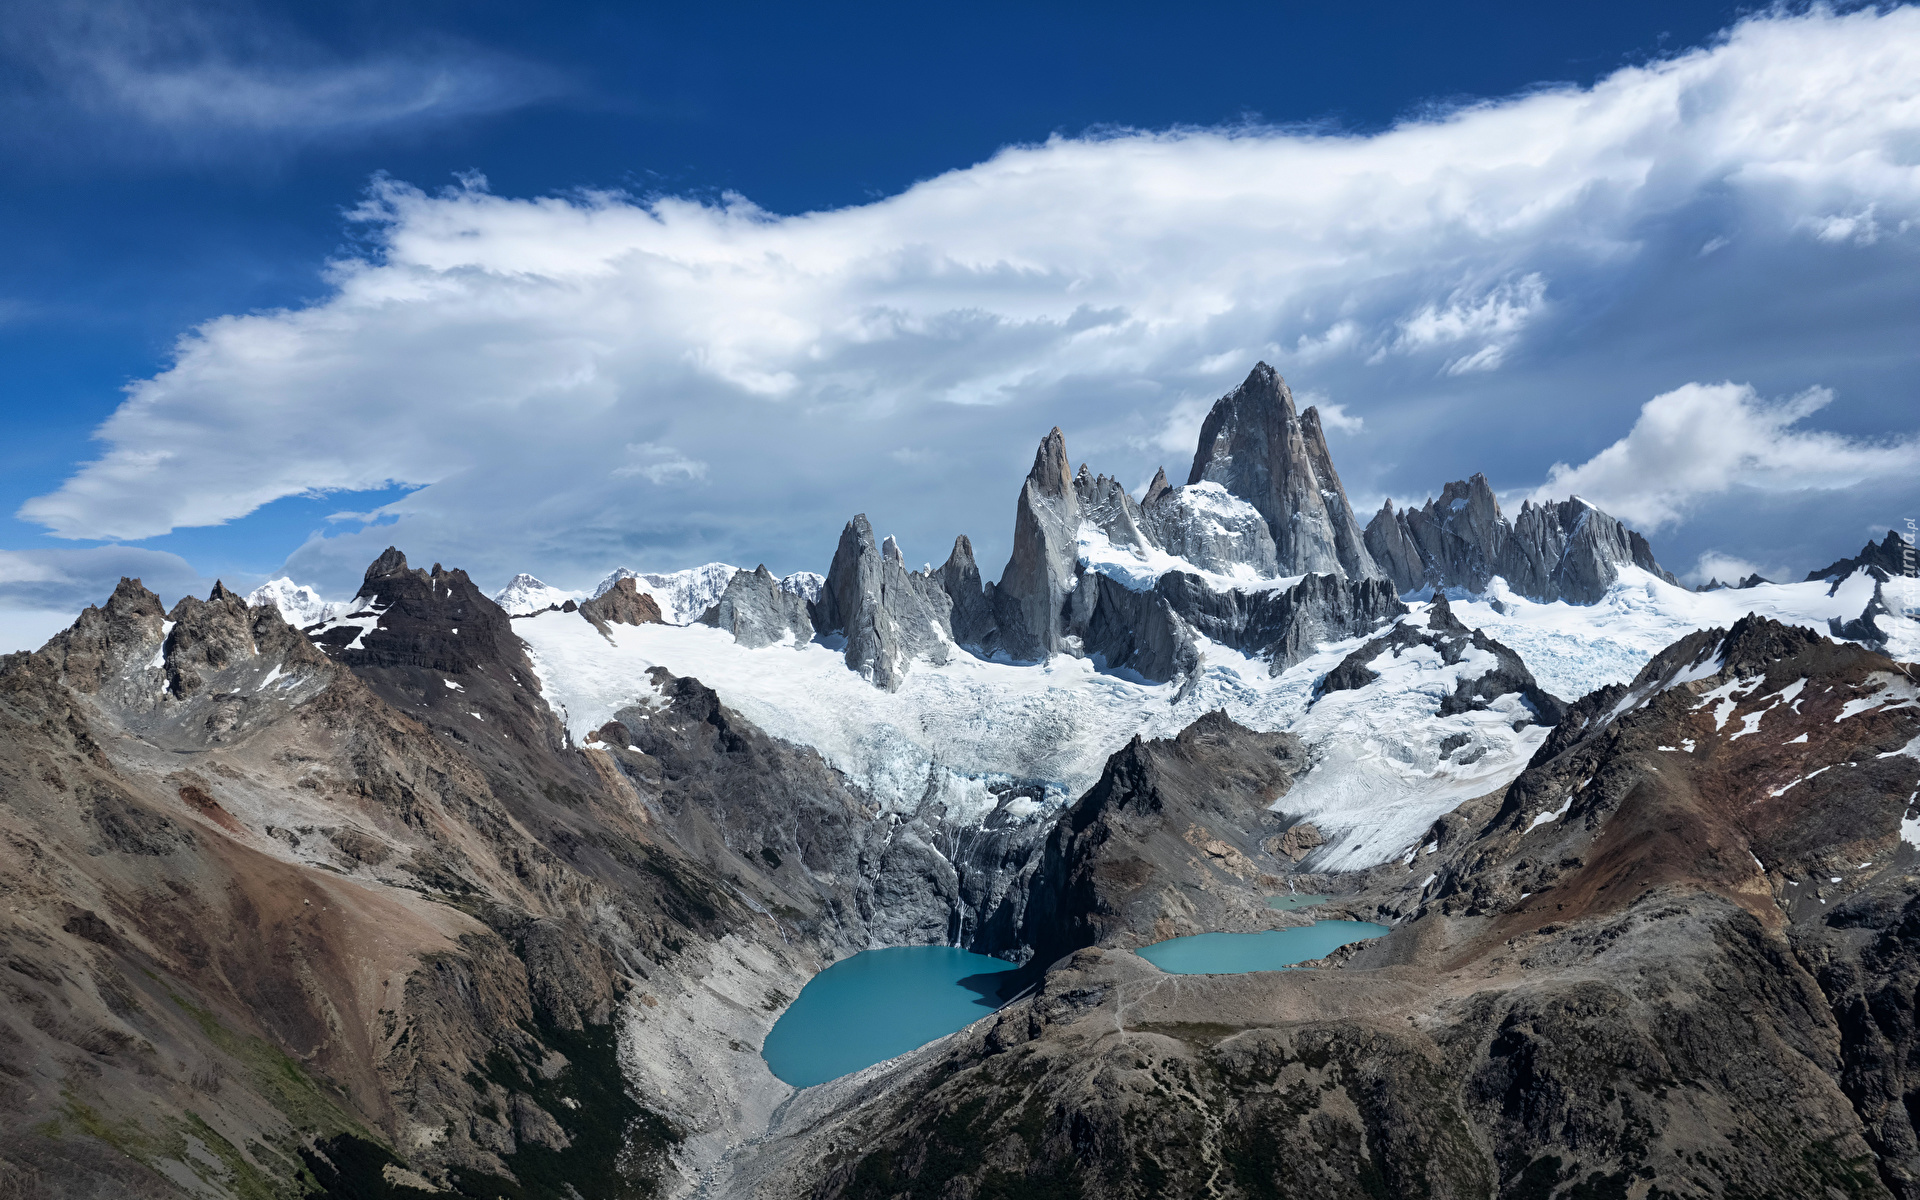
[{"xmin": 1534, "ymin": 384, "xmax": 1920, "ymax": 530}]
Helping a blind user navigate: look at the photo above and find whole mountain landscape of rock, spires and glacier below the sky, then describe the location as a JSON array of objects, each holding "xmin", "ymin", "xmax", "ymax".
[{"xmin": 0, "ymin": 365, "xmax": 1920, "ymax": 1200}]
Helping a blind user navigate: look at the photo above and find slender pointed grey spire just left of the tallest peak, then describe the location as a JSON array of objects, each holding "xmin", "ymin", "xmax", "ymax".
[{"xmin": 993, "ymin": 426, "xmax": 1081, "ymax": 662}]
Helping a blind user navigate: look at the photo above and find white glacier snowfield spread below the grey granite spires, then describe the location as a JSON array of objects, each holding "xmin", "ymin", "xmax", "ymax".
[{"xmin": 515, "ymin": 560, "xmax": 1920, "ymax": 872}]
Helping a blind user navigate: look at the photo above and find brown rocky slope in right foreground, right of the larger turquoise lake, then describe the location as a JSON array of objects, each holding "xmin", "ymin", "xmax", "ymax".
[{"xmin": 721, "ymin": 618, "xmax": 1920, "ymax": 1200}]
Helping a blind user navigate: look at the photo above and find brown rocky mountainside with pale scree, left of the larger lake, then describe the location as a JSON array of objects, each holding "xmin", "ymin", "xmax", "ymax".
[{"xmin": 0, "ymin": 551, "xmax": 1067, "ymax": 1198}]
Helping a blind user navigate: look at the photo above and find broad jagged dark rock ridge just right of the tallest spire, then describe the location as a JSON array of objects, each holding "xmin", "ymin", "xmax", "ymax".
[{"xmin": 1367, "ymin": 474, "xmax": 1676, "ymax": 605}]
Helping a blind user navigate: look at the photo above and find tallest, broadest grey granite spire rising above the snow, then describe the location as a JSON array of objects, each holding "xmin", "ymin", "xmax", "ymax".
[{"xmin": 1187, "ymin": 363, "xmax": 1382, "ymax": 580}]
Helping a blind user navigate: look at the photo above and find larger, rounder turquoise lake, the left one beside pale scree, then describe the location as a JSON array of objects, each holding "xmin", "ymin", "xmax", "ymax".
[{"xmin": 760, "ymin": 947, "xmax": 1021, "ymax": 1087}]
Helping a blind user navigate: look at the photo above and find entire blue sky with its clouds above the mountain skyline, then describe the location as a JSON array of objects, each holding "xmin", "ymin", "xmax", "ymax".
[{"xmin": 0, "ymin": 4, "xmax": 1920, "ymax": 649}]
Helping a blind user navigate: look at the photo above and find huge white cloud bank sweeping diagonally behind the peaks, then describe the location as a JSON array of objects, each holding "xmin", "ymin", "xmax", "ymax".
[{"xmin": 19, "ymin": 8, "xmax": 1920, "ymax": 580}]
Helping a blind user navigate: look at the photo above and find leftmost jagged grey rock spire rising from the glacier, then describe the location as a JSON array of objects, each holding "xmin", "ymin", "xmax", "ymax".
[{"xmin": 812, "ymin": 513, "xmax": 954, "ymax": 691}]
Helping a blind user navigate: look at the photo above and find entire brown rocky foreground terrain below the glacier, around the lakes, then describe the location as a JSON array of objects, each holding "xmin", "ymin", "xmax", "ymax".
[{"xmin": 0, "ymin": 551, "xmax": 1920, "ymax": 1200}]
